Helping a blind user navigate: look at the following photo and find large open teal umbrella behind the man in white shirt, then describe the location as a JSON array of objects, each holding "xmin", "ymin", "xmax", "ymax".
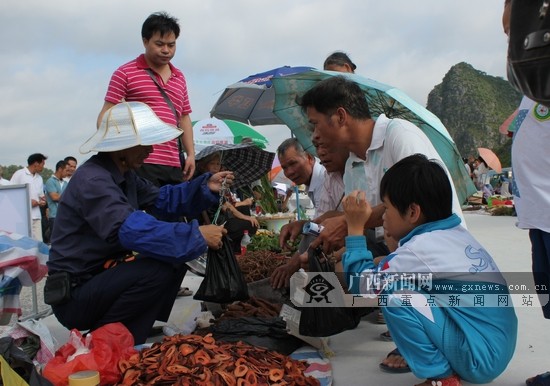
[{"xmin": 272, "ymin": 70, "xmax": 476, "ymax": 202}]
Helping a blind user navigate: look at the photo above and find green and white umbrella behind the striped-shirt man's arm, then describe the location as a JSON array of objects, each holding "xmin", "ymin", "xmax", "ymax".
[{"xmin": 193, "ymin": 118, "xmax": 269, "ymax": 151}]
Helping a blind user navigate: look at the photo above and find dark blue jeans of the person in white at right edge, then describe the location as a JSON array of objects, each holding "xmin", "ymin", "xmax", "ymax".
[{"xmin": 529, "ymin": 229, "xmax": 550, "ymax": 319}]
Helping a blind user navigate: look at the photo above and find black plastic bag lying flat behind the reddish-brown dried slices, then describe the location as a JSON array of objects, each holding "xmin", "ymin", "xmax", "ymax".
[{"xmin": 209, "ymin": 316, "xmax": 304, "ymax": 355}]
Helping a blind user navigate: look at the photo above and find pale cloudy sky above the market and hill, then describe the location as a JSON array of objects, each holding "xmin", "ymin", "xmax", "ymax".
[{"xmin": 0, "ymin": 0, "xmax": 507, "ymax": 169}]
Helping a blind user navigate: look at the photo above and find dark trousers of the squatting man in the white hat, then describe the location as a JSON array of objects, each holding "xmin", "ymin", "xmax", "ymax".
[{"xmin": 52, "ymin": 258, "xmax": 187, "ymax": 345}]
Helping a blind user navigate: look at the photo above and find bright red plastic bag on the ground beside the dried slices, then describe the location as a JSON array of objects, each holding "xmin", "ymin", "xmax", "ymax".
[{"xmin": 42, "ymin": 323, "xmax": 136, "ymax": 386}]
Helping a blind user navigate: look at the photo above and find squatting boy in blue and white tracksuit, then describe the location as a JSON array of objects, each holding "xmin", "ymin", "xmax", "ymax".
[{"xmin": 342, "ymin": 154, "xmax": 517, "ymax": 386}]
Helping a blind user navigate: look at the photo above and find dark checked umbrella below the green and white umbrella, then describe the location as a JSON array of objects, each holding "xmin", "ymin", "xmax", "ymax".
[{"xmin": 195, "ymin": 144, "xmax": 275, "ymax": 189}]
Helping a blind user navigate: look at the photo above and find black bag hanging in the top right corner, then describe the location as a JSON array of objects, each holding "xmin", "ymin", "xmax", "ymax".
[{"xmin": 507, "ymin": 0, "xmax": 550, "ymax": 106}]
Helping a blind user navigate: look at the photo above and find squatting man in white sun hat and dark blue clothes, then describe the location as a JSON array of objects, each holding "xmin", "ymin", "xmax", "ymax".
[{"xmin": 44, "ymin": 102, "xmax": 233, "ymax": 344}]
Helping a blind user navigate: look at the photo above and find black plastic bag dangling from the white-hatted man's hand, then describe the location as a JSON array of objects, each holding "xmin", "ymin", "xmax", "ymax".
[{"xmin": 193, "ymin": 236, "xmax": 248, "ymax": 303}]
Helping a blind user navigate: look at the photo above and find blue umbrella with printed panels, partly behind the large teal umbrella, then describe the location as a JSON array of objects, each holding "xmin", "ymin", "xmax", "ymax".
[{"xmin": 210, "ymin": 66, "xmax": 311, "ymax": 126}]
